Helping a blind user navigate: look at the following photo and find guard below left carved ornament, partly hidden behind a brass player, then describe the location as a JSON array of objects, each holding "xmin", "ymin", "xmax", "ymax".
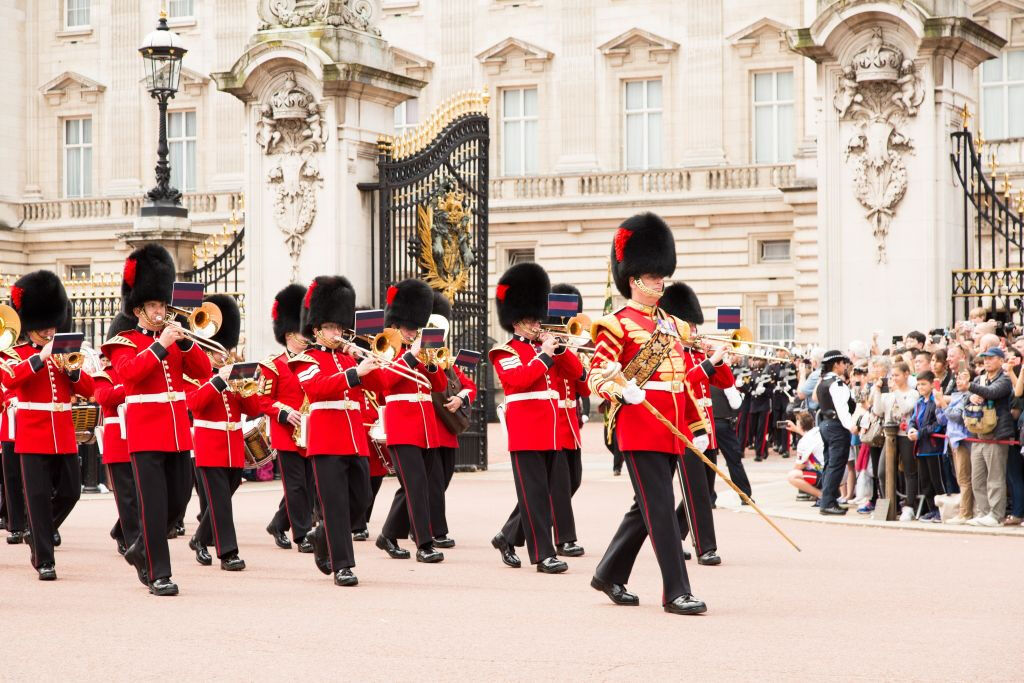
[{"xmin": 259, "ymin": 285, "xmax": 313, "ymax": 553}]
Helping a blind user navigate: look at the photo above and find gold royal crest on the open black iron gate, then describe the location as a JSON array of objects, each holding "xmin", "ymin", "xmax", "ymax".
[{"xmin": 416, "ymin": 177, "xmax": 476, "ymax": 301}]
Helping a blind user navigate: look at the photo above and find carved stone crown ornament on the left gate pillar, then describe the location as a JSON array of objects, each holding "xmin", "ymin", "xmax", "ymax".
[{"xmin": 256, "ymin": 73, "xmax": 328, "ymax": 283}]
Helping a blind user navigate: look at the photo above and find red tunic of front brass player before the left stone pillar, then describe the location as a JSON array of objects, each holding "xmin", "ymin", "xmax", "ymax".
[{"xmin": 288, "ymin": 345, "xmax": 380, "ymax": 456}]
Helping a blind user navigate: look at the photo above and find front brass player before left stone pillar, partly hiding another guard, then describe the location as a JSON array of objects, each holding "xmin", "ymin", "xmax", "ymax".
[{"xmin": 289, "ymin": 275, "xmax": 380, "ymax": 586}]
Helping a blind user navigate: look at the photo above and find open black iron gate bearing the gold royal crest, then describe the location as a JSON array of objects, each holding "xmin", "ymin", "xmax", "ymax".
[{"xmin": 376, "ymin": 93, "xmax": 489, "ymax": 470}]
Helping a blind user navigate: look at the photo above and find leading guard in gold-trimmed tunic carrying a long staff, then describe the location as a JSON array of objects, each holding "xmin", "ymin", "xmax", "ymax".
[{"xmin": 589, "ymin": 213, "xmax": 708, "ymax": 614}]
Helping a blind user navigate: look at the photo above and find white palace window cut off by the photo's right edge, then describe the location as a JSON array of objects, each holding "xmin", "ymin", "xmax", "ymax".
[{"xmin": 981, "ymin": 50, "xmax": 1024, "ymax": 140}]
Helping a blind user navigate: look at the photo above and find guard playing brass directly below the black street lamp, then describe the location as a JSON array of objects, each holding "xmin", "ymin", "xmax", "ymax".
[{"xmin": 102, "ymin": 244, "xmax": 211, "ymax": 595}]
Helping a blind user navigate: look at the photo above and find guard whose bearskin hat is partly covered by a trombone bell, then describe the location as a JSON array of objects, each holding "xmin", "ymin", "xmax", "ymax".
[{"xmin": 185, "ymin": 294, "xmax": 261, "ymax": 571}]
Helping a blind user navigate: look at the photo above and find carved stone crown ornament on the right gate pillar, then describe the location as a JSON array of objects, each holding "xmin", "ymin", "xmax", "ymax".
[{"xmin": 833, "ymin": 29, "xmax": 925, "ymax": 263}]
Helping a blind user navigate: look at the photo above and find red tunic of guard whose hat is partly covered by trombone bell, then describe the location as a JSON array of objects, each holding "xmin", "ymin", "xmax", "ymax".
[{"xmin": 185, "ymin": 375, "xmax": 261, "ymax": 468}]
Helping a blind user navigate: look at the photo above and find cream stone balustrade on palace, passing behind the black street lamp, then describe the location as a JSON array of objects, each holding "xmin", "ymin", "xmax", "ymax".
[{"xmin": 12, "ymin": 193, "xmax": 242, "ymax": 223}]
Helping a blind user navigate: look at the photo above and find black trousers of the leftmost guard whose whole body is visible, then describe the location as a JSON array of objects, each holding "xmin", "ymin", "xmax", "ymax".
[{"xmin": 20, "ymin": 454, "xmax": 82, "ymax": 568}]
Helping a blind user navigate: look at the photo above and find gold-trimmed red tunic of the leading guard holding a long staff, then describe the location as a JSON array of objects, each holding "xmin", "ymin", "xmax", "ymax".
[{"xmin": 588, "ymin": 301, "xmax": 714, "ymax": 455}]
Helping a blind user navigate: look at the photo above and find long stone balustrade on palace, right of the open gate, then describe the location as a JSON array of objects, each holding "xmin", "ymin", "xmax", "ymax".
[{"xmin": 490, "ymin": 164, "xmax": 796, "ymax": 201}]
